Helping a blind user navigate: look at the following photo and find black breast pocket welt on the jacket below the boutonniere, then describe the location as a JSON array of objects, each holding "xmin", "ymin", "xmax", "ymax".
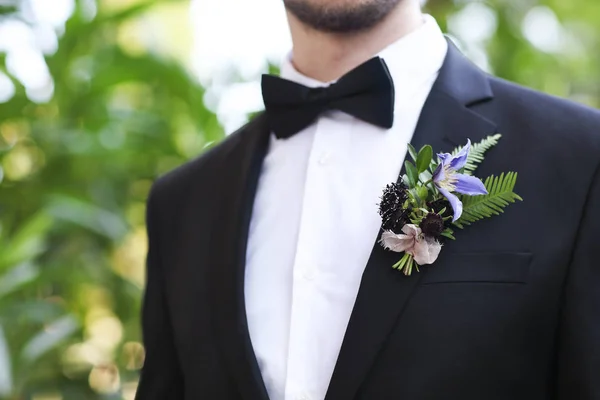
[{"xmin": 420, "ymin": 252, "xmax": 533, "ymax": 285}]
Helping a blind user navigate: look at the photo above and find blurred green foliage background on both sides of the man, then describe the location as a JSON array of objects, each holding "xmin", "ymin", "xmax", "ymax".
[{"xmin": 0, "ymin": 0, "xmax": 600, "ymax": 400}]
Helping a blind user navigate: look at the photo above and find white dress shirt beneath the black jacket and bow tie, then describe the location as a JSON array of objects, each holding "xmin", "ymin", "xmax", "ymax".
[{"xmin": 245, "ymin": 15, "xmax": 447, "ymax": 400}]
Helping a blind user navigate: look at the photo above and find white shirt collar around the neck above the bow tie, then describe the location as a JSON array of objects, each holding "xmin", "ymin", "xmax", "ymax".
[{"xmin": 280, "ymin": 14, "xmax": 448, "ymax": 96}]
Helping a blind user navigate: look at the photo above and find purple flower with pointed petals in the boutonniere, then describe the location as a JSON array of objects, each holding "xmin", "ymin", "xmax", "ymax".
[{"xmin": 433, "ymin": 140, "xmax": 488, "ymax": 222}]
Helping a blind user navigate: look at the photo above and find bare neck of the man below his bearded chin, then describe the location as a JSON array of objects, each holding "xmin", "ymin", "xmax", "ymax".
[{"xmin": 288, "ymin": 1, "xmax": 423, "ymax": 82}]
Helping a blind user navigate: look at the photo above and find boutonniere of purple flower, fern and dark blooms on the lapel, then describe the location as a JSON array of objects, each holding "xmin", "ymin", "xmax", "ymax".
[{"xmin": 379, "ymin": 134, "xmax": 522, "ymax": 275}]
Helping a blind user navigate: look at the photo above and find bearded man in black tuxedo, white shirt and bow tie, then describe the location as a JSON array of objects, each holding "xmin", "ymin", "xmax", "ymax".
[{"xmin": 137, "ymin": 0, "xmax": 600, "ymax": 400}]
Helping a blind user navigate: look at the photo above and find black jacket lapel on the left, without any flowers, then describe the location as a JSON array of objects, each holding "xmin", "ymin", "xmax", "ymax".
[{"xmin": 209, "ymin": 114, "xmax": 269, "ymax": 400}]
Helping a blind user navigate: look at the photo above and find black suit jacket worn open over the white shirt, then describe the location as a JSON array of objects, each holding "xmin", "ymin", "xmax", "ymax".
[{"xmin": 137, "ymin": 42, "xmax": 600, "ymax": 400}]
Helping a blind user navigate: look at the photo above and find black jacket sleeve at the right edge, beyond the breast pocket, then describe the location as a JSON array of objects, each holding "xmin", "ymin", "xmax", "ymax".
[{"xmin": 557, "ymin": 162, "xmax": 600, "ymax": 400}]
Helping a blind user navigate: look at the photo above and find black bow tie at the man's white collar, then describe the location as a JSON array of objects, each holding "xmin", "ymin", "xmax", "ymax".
[{"xmin": 262, "ymin": 57, "xmax": 394, "ymax": 139}]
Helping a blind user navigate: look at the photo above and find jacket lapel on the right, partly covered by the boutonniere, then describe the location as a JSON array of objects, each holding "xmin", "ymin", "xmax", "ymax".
[{"xmin": 326, "ymin": 38, "xmax": 496, "ymax": 400}]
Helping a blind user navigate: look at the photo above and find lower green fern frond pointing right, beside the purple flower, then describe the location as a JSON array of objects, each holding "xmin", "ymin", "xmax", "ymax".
[{"xmin": 454, "ymin": 172, "xmax": 523, "ymax": 228}]
